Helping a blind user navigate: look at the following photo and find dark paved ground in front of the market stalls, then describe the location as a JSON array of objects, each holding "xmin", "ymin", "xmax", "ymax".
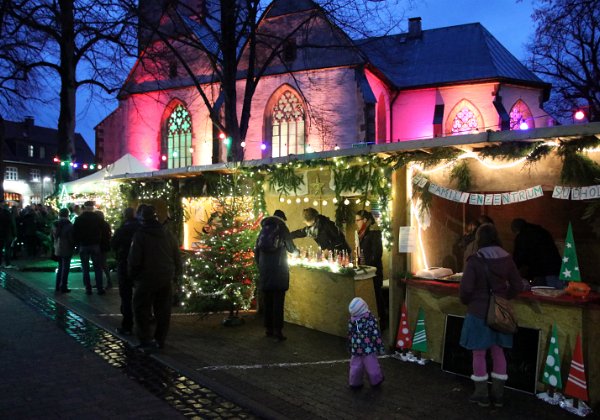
[{"xmin": 0, "ymin": 260, "xmax": 592, "ymax": 419}]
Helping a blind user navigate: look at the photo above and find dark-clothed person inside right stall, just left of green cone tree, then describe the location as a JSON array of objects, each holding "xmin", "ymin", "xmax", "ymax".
[{"xmin": 510, "ymin": 219, "xmax": 564, "ymax": 289}]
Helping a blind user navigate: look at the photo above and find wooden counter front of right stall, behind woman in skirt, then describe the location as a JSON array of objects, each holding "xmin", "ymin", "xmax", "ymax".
[{"xmin": 402, "ymin": 279, "xmax": 600, "ymax": 403}]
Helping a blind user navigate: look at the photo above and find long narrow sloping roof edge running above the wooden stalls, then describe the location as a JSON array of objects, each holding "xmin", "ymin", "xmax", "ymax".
[{"xmin": 105, "ymin": 122, "xmax": 600, "ymax": 179}]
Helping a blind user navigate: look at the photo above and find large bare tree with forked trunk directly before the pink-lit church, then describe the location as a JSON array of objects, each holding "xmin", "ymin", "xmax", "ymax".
[{"xmin": 122, "ymin": 0, "xmax": 401, "ymax": 161}]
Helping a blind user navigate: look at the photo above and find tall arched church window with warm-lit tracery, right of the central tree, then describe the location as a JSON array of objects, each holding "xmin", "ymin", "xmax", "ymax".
[{"xmin": 271, "ymin": 90, "xmax": 306, "ymax": 157}]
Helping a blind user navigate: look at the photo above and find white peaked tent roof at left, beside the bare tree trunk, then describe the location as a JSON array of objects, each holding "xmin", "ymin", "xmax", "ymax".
[{"xmin": 61, "ymin": 153, "xmax": 153, "ymax": 194}]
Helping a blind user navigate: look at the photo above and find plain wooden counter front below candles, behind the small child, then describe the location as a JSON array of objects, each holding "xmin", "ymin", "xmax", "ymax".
[{"xmin": 284, "ymin": 266, "xmax": 377, "ymax": 337}]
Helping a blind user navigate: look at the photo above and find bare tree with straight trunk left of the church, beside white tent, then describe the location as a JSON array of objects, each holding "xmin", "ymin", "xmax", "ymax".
[{"xmin": 8, "ymin": 0, "xmax": 136, "ymax": 186}]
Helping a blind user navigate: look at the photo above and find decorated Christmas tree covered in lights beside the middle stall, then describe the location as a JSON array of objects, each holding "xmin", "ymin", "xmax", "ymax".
[{"xmin": 182, "ymin": 174, "xmax": 261, "ymax": 325}]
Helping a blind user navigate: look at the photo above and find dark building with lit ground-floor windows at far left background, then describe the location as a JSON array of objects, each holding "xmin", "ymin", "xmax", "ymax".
[{"xmin": 3, "ymin": 117, "xmax": 95, "ymax": 206}]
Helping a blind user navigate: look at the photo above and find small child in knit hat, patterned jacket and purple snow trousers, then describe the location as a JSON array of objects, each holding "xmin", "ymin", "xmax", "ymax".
[{"xmin": 348, "ymin": 297, "xmax": 385, "ymax": 389}]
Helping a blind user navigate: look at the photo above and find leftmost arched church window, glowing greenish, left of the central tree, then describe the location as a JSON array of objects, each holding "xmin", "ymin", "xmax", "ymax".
[{"xmin": 166, "ymin": 105, "xmax": 192, "ymax": 168}]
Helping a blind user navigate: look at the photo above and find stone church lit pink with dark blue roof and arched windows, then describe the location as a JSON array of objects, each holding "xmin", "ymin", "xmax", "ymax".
[{"xmin": 96, "ymin": 0, "xmax": 553, "ymax": 169}]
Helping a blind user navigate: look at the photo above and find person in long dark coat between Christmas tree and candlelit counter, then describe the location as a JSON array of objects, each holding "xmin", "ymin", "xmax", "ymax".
[{"xmin": 254, "ymin": 210, "xmax": 298, "ymax": 341}]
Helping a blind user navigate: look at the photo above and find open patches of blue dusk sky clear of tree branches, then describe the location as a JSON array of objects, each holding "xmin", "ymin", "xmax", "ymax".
[{"xmin": 34, "ymin": 0, "xmax": 533, "ymax": 154}]
